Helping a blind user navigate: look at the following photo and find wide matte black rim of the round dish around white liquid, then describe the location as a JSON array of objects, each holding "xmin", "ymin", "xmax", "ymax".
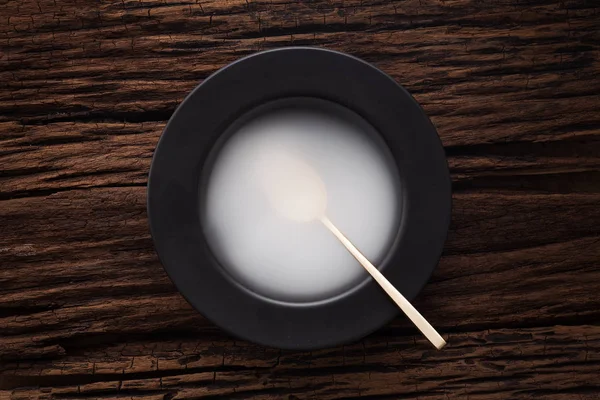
[{"xmin": 148, "ymin": 47, "xmax": 451, "ymax": 349}]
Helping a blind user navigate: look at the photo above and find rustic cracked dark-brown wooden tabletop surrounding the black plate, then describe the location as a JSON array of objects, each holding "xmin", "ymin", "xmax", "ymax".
[{"xmin": 0, "ymin": 0, "xmax": 600, "ymax": 400}]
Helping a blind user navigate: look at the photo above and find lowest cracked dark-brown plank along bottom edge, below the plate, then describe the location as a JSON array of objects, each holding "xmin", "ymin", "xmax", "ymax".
[{"xmin": 3, "ymin": 326, "xmax": 600, "ymax": 399}]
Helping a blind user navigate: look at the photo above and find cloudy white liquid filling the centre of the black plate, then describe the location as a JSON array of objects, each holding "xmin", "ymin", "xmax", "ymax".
[{"xmin": 201, "ymin": 103, "xmax": 401, "ymax": 302}]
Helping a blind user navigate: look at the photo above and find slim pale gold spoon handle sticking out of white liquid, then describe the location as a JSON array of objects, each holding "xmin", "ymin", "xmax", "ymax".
[{"xmin": 321, "ymin": 216, "xmax": 446, "ymax": 350}]
